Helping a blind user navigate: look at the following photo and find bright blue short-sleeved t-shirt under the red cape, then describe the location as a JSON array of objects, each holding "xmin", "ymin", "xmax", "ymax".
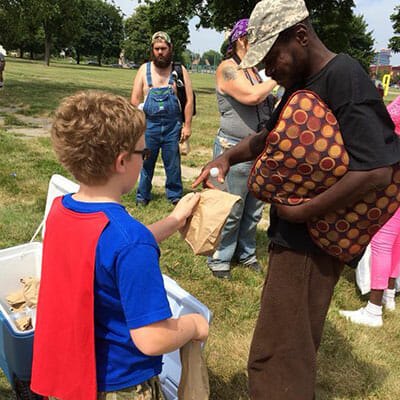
[{"xmin": 62, "ymin": 194, "xmax": 172, "ymax": 392}]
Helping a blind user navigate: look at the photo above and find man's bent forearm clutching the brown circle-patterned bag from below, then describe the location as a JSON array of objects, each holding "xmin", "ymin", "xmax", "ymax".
[{"xmin": 276, "ymin": 167, "xmax": 392, "ymax": 223}]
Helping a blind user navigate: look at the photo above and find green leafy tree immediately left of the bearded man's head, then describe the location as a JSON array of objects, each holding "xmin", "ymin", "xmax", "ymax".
[{"xmin": 124, "ymin": 5, "xmax": 152, "ymax": 64}]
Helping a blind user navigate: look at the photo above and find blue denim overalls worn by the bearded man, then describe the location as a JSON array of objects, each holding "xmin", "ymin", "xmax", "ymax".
[{"xmin": 136, "ymin": 63, "xmax": 182, "ymax": 202}]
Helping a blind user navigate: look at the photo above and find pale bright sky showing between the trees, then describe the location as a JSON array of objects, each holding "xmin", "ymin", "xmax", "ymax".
[{"xmin": 114, "ymin": 0, "xmax": 400, "ymax": 65}]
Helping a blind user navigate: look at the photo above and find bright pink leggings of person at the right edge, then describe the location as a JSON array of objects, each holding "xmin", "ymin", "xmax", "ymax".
[{"xmin": 371, "ymin": 208, "xmax": 400, "ymax": 290}]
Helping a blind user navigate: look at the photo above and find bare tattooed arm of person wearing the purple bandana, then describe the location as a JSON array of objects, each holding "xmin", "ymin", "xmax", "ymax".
[{"xmin": 216, "ymin": 60, "xmax": 276, "ymax": 105}]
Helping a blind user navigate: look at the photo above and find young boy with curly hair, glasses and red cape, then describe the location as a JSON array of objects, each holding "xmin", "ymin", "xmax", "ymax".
[{"xmin": 31, "ymin": 91, "xmax": 208, "ymax": 400}]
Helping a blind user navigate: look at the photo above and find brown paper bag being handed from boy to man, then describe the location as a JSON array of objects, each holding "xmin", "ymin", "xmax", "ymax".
[{"xmin": 181, "ymin": 189, "xmax": 241, "ymax": 256}]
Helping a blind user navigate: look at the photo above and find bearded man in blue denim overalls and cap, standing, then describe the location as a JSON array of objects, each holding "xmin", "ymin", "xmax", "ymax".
[{"xmin": 131, "ymin": 32, "xmax": 193, "ymax": 206}]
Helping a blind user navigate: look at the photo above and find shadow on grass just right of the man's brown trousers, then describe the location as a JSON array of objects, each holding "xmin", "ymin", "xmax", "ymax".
[{"xmin": 316, "ymin": 321, "xmax": 389, "ymax": 400}]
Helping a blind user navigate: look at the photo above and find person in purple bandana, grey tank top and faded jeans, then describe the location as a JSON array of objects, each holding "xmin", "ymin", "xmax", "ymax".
[{"xmin": 208, "ymin": 19, "xmax": 276, "ymax": 279}]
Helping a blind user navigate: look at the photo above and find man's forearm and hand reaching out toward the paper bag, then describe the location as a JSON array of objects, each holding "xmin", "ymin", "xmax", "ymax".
[{"xmin": 191, "ymin": 130, "xmax": 267, "ymax": 188}]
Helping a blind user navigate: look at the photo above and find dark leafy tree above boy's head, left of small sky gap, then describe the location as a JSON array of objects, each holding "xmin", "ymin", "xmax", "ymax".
[{"xmin": 73, "ymin": 0, "xmax": 124, "ymax": 65}]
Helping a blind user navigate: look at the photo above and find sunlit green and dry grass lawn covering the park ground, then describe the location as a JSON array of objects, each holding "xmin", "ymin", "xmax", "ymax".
[{"xmin": 0, "ymin": 58, "xmax": 400, "ymax": 400}]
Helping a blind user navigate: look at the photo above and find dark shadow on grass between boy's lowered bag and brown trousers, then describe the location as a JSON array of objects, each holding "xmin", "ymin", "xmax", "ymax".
[{"xmin": 208, "ymin": 370, "xmax": 249, "ymax": 400}]
